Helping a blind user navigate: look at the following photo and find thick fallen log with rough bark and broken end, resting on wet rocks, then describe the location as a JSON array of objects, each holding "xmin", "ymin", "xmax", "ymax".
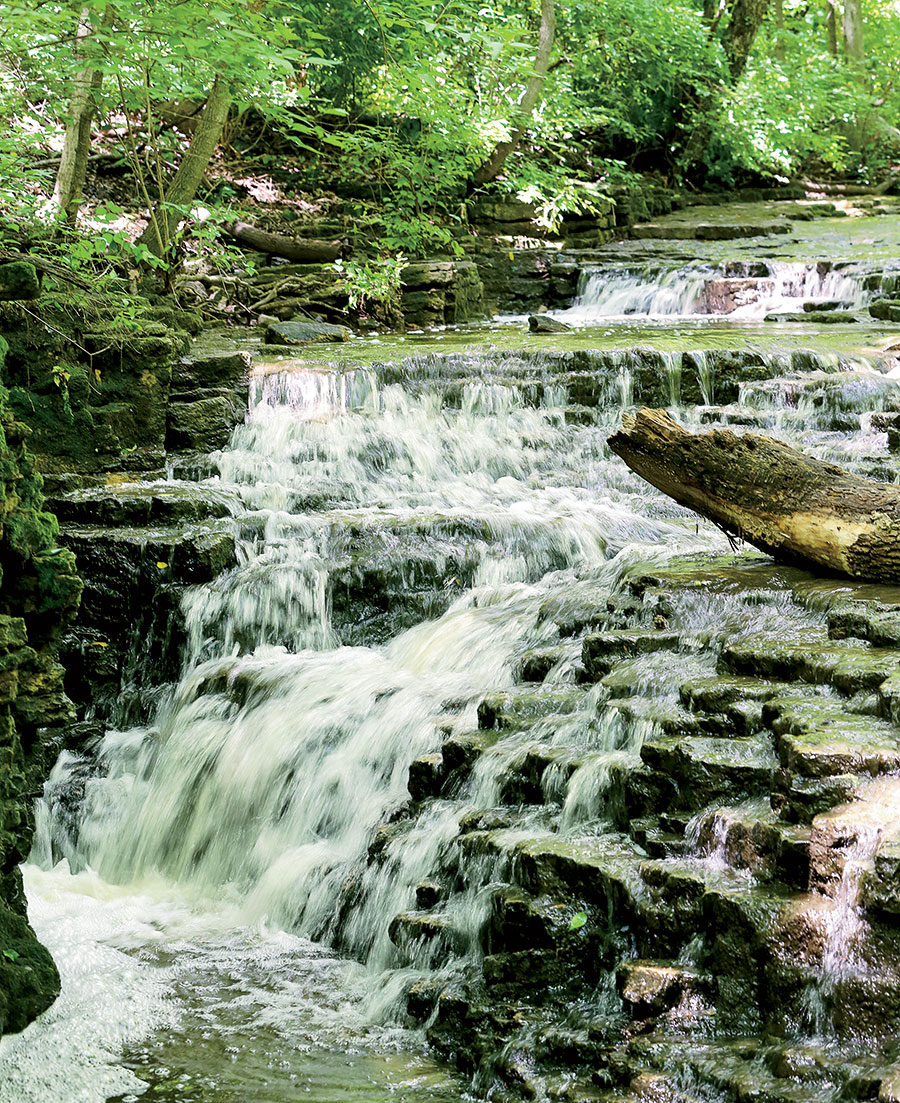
[{"xmin": 608, "ymin": 408, "xmax": 900, "ymax": 582}]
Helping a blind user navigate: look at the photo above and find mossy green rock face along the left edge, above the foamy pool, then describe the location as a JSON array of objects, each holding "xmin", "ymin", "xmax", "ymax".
[{"xmin": 0, "ymin": 336, "xmax": 82, "ymax": 1034}]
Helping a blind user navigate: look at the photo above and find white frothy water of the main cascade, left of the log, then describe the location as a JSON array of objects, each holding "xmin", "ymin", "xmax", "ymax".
[{"xmin": 7, "ymin": 359, "xmax": 724, "ymax": 1103}]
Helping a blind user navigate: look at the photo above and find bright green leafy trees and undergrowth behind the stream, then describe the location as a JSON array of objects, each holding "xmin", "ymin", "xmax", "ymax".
[{"xmin": 0, "ymin": 0, "xmax": 900, "ymax": 259}]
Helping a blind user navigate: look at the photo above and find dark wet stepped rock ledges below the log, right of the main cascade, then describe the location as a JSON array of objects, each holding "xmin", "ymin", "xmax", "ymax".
[{"xmin": 392, "ymin": 561, "xmax": 900, "ymax": 1103}]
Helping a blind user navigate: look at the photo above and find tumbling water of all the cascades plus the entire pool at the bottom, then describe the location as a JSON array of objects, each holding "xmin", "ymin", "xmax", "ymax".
[{"xmin": 0, "ymin": 217, "xmax": 900, "ymax": 1103}]
